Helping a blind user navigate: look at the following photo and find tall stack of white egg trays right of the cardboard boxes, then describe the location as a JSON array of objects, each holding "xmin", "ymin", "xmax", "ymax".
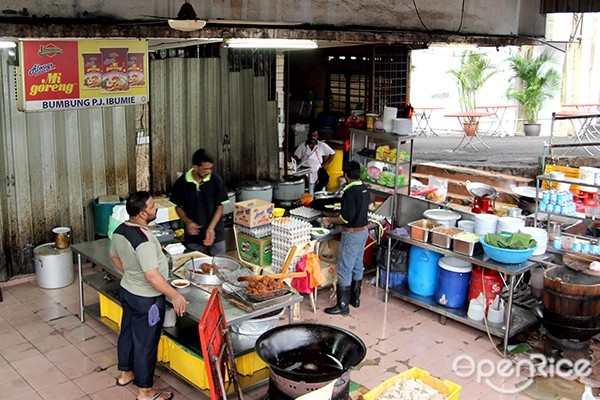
[{"xmin": 271, "ymin": 218, "xmax": 312, "ymax": 273}]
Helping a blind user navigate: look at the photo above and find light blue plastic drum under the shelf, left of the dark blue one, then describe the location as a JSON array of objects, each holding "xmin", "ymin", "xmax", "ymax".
[{"xmin": 408, "ymin": 246, "xmax": 442, "ymax": 296}]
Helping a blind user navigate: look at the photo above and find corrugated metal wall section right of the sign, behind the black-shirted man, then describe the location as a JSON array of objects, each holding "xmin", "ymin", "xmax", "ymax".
[{"xmin": 150, "ymin": 48, "xmax": 279, "ymax": 193}]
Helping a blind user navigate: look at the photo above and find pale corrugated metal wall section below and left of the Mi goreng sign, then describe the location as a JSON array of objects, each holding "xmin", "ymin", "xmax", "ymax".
[{"xmin": 0, "ymin": 51, "xmax": 135, "ymax": 281}]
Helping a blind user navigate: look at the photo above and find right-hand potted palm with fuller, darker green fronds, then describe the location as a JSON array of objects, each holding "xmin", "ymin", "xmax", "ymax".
[{"xmin": 506, "ymin": 51, "xmax": 560, "ymax": 136}]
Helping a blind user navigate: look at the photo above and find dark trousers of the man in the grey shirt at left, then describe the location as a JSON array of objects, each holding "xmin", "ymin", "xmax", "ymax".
[{"xmin": 117, "ymin": 288, "xmax": 165, "ymax": 388}]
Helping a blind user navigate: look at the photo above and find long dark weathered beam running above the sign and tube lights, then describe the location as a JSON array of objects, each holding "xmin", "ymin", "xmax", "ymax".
[{"xmin": 0, "ymin": 18, "xmax": 536, "ymax": 48}]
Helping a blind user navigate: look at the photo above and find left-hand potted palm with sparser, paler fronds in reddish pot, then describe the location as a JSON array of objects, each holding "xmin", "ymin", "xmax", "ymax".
[{"xmin": 448, "ymin": 51, "xmax": 498, "ymax": 136}]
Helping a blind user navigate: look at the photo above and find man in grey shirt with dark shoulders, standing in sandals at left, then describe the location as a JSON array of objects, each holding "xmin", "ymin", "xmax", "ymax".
[{"xmin": 110, "ymin": 192, "xmax": 188, "ymax": 400}]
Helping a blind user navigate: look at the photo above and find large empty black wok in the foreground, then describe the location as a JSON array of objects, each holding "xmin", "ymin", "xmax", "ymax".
[{"xmin": 255, "ymin": 324, "xmax": 367, "ymax": 383}]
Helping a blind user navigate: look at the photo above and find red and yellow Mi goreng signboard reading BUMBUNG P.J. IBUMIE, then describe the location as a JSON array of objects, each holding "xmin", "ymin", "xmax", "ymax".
[{"xmin": 17, "ymin": 40, "xmax": 149, "ymax": 111}]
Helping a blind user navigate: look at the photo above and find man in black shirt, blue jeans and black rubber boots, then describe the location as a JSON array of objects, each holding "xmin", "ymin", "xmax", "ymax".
[{"xmin": 323, "ymin": 161, "xmax": 371, "ymax": 315}]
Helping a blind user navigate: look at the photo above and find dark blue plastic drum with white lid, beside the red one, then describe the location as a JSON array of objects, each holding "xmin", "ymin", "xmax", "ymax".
[{"xmin": 435, "ymin": 257, "xmax": 473, "ymax": 308}]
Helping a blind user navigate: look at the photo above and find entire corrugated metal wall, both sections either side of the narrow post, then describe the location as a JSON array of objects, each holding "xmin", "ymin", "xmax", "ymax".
[{"xmin": 0, "ymin": 45, "xmax": 278, "ymax": 281}]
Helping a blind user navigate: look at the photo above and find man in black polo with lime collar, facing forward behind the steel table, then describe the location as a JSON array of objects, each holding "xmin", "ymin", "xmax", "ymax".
[{"xmin": 170, "ymin": 149, "xmax": 229, "ymax": 256}]
